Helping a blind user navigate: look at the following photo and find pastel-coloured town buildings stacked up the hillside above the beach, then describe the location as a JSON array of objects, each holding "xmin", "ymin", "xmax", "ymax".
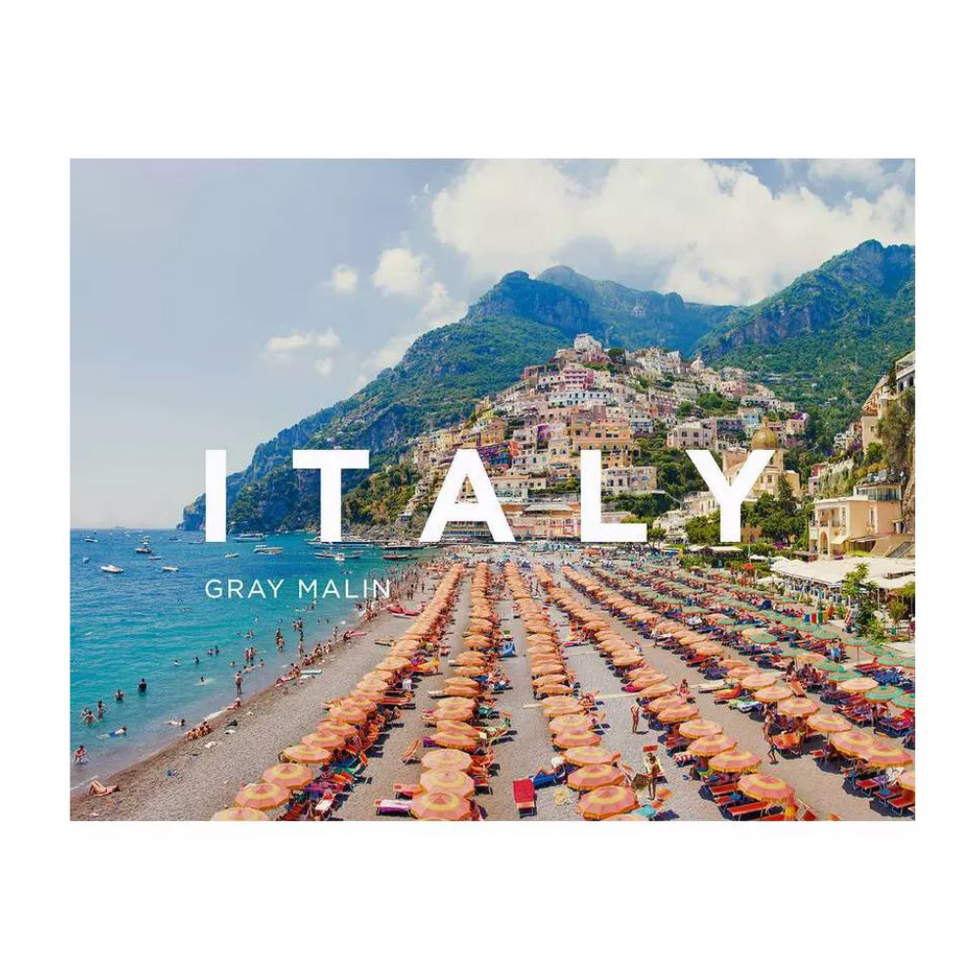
[{"xmin": 394, "ymin": 334, "xmax": 915, "ymax": 592}]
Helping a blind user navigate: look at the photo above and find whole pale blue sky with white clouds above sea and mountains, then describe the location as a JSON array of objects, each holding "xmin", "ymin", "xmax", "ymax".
[{"xmin": 71, "ymin": 159, "xmax": 915, "ymax": 528}]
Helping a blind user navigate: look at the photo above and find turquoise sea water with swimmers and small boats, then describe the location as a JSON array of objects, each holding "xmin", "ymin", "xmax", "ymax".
[{"xmin": 70, "ymin": 529, "xmax": 414, "ymax": 785}]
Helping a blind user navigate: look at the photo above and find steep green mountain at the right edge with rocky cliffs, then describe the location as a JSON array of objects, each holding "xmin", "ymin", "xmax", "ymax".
[{"xmin": 699, "ymin": 241, "xmax": 915, "ymax": 431}]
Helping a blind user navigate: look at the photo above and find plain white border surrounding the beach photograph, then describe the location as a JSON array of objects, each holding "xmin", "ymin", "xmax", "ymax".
[{"xmin": 0, "ymin": 0, "xmax": 980, "ymax": 977}]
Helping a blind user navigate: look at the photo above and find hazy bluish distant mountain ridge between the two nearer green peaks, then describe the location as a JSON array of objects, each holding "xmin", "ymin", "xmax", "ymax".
[{"xmin": 537, "ymin": 265, "xmax": 738, "ymax": 356}]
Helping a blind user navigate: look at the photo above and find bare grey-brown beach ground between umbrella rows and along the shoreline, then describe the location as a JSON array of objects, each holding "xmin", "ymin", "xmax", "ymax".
[{"xmin": 71, "ymin": 554, "xmax": 916, "ymax": 820}]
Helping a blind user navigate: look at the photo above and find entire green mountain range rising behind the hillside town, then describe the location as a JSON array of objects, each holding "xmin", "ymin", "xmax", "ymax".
[{"xmin": 181, "ymin": 242, "xmax": 915, "ymax": 531}]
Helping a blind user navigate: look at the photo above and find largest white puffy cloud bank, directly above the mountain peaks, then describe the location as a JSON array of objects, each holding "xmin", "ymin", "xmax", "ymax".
[{"xmin": 431, "ymin": 160, "xmax": 915, "ymax": 303}]
